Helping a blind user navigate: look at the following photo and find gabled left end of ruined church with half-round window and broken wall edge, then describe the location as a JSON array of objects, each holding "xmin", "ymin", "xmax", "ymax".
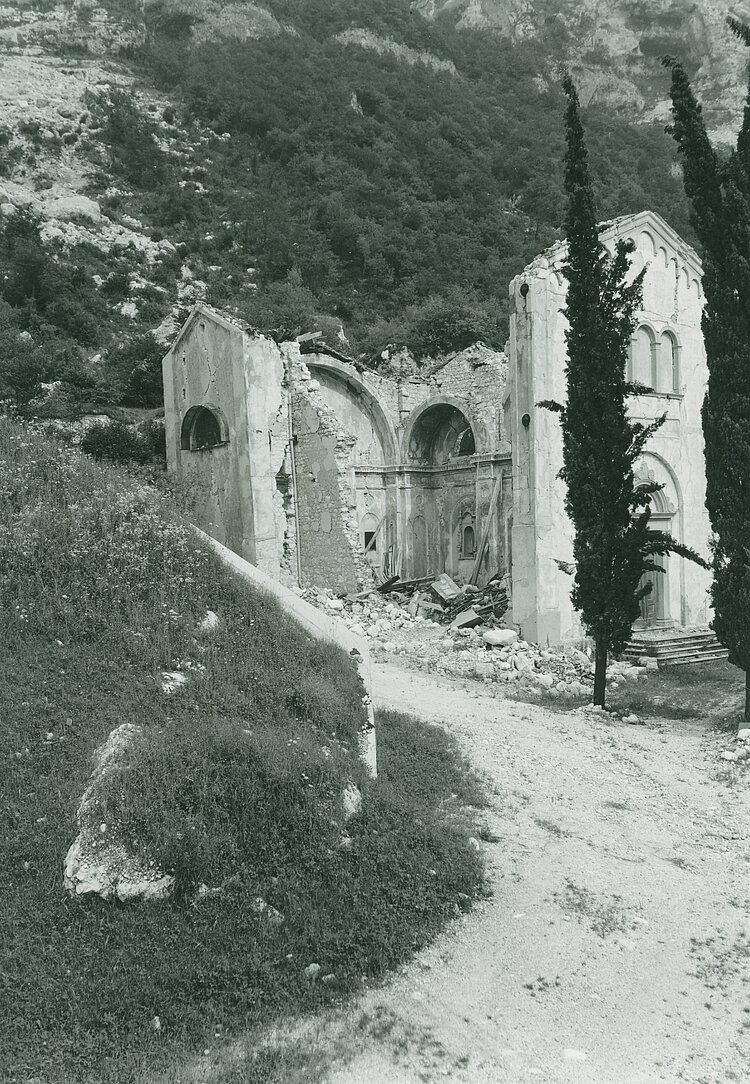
[{"xmin": 164, "ymin": 305, "xmax": 372, "ymax": 591}]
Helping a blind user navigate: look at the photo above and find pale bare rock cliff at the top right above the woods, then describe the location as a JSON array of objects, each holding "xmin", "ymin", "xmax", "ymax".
[{"xmin": 416, "ymin": 0, "xmax": 750, "ymax": 141}]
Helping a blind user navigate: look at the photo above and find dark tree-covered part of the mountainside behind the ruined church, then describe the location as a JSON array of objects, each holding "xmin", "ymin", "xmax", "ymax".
[{"xmin": 0, "ymin": 0, "xmax": 691, "ymax": 403}]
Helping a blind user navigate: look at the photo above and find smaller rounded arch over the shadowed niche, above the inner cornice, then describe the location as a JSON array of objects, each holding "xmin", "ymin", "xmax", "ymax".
[{"xmin": 401, "ymin": 396, "xmax": 488, "ymax": 466}]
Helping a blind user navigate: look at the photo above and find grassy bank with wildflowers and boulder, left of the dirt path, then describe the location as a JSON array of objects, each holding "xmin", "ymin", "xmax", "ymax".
[{"xmin": 0, "ymin": 421, "xmax": 481, "ymax": 1084}]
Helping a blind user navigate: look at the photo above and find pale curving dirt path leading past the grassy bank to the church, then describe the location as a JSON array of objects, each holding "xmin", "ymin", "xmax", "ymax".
[{"xmin": 316, "ymin": 664, "xmax": 750, "ymax": 1084}]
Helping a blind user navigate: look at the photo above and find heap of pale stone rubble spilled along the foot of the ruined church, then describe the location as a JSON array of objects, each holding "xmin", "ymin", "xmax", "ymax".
[{"xmin": 302, "ymin": 588, "xmax": 645, "ymax": 700}]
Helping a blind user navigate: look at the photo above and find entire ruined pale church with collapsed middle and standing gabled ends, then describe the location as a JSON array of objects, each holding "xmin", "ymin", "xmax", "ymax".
[{"xmin": 164, "ymin": 211, "xmax": 710, "ymax": 644}]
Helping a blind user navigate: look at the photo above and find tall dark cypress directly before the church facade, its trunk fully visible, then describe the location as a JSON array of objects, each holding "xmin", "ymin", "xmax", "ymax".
[{"xmin": 540, "ymin": 77, "xmax": 700, "ymax": 707}]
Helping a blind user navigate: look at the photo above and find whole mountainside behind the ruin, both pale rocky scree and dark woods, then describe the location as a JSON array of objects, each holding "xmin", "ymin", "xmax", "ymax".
[{"xmin": 0, "ymin": 0, "xmax": 743, "ymax": 407}]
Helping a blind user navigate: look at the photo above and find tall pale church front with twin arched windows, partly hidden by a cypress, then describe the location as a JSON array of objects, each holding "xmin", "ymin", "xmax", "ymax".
[{"xmin": 506, "ymin": 212, "xmax": 710, "ymax": 644}]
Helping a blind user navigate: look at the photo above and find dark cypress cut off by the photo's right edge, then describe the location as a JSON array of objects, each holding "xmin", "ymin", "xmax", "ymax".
[{"xmin": 664, "ymin": 18, "xmax": 750, "ymax": 720}]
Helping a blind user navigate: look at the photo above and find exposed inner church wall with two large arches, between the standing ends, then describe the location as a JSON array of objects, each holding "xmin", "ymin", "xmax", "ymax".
[{"xmin": 306, "ymin": 345, "xmax": 512, "ymax": 582}]
